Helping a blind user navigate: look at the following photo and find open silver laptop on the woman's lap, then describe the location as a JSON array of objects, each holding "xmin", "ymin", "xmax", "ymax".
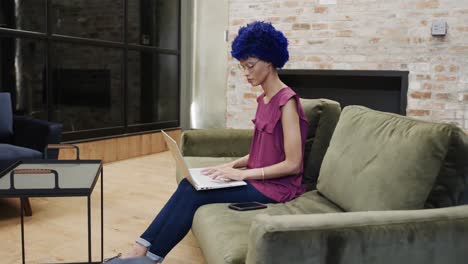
[{"xmin": 161, "ymin": 130, "xmax": 247, "ymax": 191}]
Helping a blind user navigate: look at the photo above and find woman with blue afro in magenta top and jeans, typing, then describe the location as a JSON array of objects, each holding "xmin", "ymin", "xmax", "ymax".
[{"xmin": 106, "ymin": 22, "xmax": 307, "ymax": 264}]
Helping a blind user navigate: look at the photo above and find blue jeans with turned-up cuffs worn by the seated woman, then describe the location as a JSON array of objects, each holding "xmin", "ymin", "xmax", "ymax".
[{"xmin": 137, "ymin": 179, "xmax": 276, "ymax": 261}]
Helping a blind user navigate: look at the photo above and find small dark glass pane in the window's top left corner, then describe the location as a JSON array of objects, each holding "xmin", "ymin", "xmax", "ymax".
[{"xmin": 0, "ymin": 0, "xmax": 46, "ymax": 32}]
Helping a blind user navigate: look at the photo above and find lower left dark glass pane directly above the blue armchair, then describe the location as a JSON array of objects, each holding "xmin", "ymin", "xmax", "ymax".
[{"xmin": 0, "ymin": 37, "xmax": 47, "ymax": 119}]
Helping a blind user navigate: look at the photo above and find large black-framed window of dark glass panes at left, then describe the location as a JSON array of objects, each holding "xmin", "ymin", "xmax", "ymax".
[{"xmin": 0, "ymin": 0, "xmax": 180, "ymax": 141}]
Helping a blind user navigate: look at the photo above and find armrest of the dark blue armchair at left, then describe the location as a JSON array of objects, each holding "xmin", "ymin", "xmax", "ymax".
[{"xmin": 13, "ymin": 116, "xmax": 62, "ymax": 158}]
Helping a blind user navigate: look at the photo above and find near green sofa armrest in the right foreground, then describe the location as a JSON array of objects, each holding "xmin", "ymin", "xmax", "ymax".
[{"xmin": 246, "ymin": 205, "xmax": 468, "ymax": 263}]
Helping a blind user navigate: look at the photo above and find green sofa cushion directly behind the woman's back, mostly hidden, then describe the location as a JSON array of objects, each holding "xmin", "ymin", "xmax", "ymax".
[{"xmin": 300, "ymin": 98, "xmax": 341, "ymax": 190}]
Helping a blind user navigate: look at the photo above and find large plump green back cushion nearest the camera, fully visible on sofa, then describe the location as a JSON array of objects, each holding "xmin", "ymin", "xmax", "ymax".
[{"xmin": 317, "ymin": 106, "xmax": 452, "ymax": 211}]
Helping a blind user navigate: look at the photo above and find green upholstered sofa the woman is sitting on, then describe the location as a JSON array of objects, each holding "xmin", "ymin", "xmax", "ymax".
[{"xmin": 177, "ymin": 99, "xmax": 468, "ymax": 264}]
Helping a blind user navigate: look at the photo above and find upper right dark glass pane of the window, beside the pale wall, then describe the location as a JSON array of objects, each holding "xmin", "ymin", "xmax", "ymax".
[{"xmin": 128, "ymin": 0, "xmax": 179, "ymax": 50}]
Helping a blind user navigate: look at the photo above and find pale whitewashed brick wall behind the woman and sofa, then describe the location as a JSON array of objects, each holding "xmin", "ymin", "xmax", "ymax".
[{"xmin": 226, "ymin": 0, "xmax": 468, "ymax": 129}]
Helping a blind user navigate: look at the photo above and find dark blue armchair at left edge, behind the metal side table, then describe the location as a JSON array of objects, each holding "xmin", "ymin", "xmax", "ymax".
[{"xmin": 0, "ymin": 93, "xmax": 62, "ymax": 215}]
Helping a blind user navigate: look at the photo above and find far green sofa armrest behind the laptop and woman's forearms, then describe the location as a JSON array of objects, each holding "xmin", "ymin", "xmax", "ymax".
[{"xmin": 181, "ymin": 129, "xmax": 253, "ymax": 157}]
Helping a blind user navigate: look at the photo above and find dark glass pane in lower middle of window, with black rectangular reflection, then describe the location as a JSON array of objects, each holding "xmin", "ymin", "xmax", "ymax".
[{"xmin": 50, "ymin": 43, "xmax": 123, "ymax": 132}]
